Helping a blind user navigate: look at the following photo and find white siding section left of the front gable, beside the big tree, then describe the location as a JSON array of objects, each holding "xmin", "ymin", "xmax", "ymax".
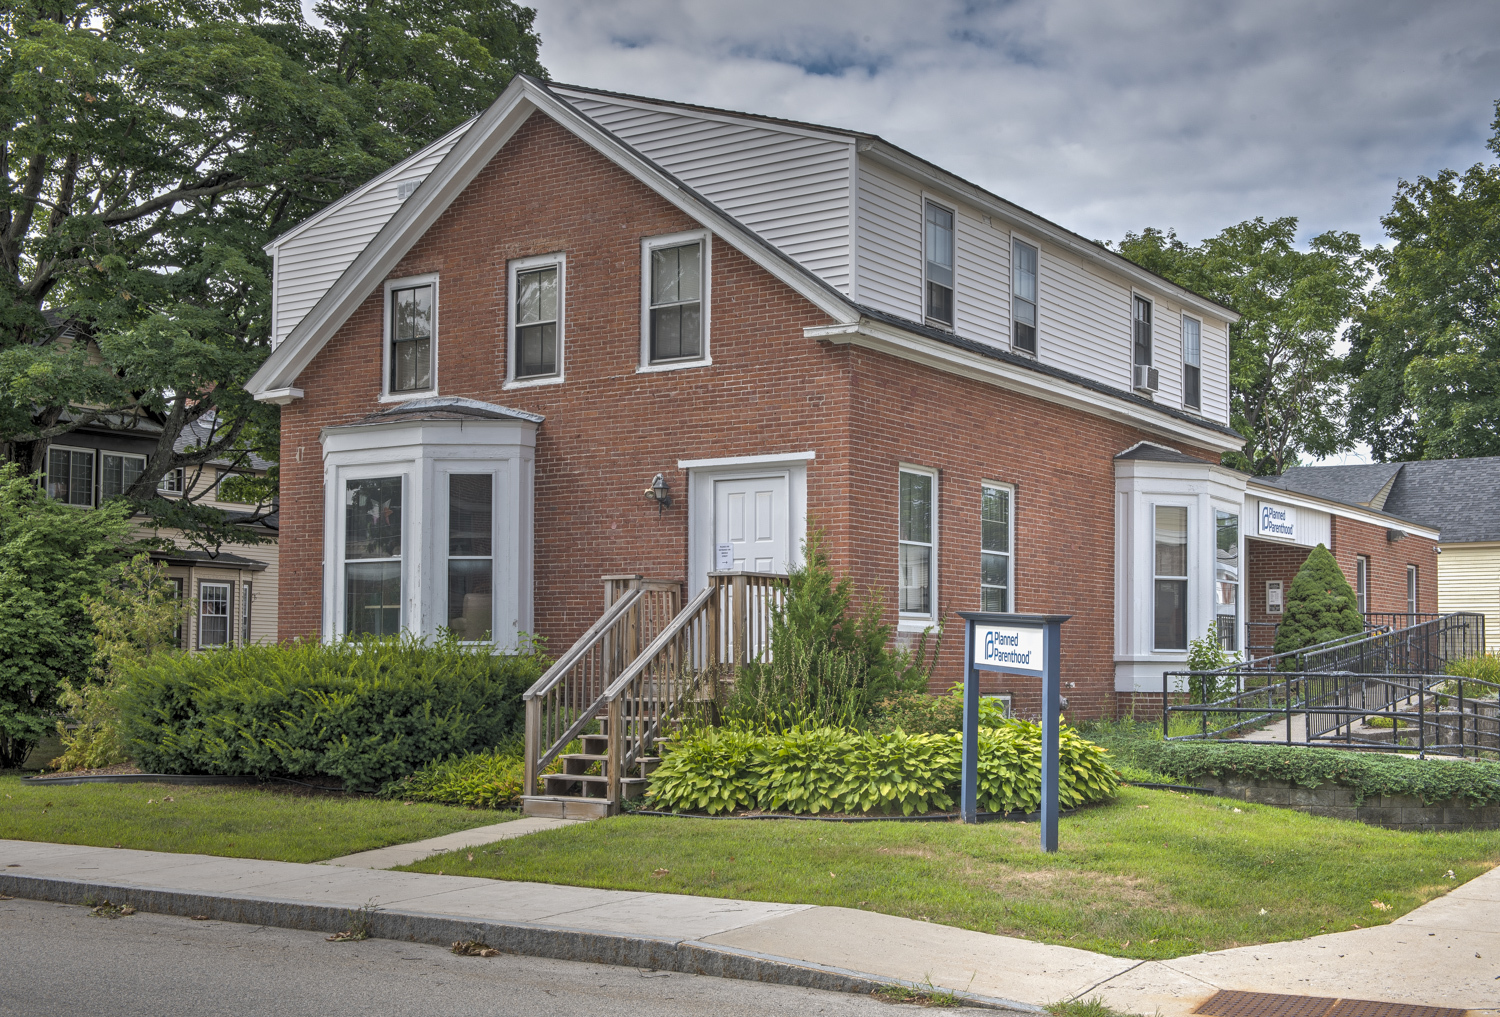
[{"xmin": 272, "ymin": 125, "xmax": 468, "ymax": 345}]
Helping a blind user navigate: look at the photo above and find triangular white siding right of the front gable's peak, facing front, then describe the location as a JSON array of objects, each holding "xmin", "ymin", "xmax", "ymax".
[{"xmin": 560, "ymin": 90, "xmax": 854, "ymax": 293}]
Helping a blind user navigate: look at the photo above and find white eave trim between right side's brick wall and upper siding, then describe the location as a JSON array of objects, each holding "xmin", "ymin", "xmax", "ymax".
[{"xmin": 803, "ymin": 318, "xmax": 1244, "ymax": 452}]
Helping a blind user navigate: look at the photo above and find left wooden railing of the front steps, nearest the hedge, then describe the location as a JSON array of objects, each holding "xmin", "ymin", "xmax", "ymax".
[{"xmin": 522, "ymin": 576, "xmax": 683, "ymax": 810}]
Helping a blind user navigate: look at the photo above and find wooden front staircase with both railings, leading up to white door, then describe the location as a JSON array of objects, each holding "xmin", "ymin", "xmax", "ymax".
[{"xmin": 525, "ymin": 572, "xmax": 788, "ymax": 818}]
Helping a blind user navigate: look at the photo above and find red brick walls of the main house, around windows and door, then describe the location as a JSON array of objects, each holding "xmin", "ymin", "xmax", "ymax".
[{"xmin": 281, "ymin": 107, "xmax": 1230, "ymax": 717}]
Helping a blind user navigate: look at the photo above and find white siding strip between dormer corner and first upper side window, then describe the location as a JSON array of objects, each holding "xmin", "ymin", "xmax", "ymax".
[{"xmin": 854, "ymin": 161, "xmax": 923, "ymax": 321}]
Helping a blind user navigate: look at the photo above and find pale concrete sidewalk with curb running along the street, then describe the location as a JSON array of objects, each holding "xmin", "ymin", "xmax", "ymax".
[{"xmin": 0, "ymin": 840, "xmax": 1500, "ymax": 1017}]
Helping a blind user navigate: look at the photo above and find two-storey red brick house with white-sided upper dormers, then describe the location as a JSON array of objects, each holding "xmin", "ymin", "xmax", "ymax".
[{"xmin": 249, "ymin": 77, "xmax": 1440, "ymax": 716}]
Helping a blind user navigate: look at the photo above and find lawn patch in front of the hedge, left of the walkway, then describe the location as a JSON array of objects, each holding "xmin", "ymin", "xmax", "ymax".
[{"xmin": 0, "ymin": 774, "xmax": 516, "ymax": 861}]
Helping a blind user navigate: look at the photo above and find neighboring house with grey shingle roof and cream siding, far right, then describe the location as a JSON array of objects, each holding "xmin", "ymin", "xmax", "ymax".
[{"xmin": 1284, "ymin": 456, "xmax": 1500, "ymax": 653}]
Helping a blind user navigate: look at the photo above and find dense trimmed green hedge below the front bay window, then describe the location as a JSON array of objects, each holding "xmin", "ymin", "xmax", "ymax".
[{"xmin": 117, "ymin": 638, "xmax": 546, "ymax": 788}]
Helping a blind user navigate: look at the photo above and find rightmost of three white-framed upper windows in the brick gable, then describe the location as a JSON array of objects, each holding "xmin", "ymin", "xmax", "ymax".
[{"xmin": 641, "ymin": 233, "xmax": 710, "ymax": 369}]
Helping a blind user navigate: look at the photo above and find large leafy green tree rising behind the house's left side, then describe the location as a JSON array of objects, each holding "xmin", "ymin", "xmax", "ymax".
[{"xmin": 0, "ymin": 0, "xmax": 545, "ymax": 546}]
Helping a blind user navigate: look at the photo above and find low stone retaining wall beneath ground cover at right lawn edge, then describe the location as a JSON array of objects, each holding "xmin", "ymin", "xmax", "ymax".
[{"xmin": 1193, "ymin": 776, "xmax": 1500, "ymax": 830}]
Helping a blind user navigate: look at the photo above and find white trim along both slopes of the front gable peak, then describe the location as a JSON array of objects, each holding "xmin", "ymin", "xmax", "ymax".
[{"xmin": 245, "ymin": 75, "xmax": 860, "ymax": 399}]
